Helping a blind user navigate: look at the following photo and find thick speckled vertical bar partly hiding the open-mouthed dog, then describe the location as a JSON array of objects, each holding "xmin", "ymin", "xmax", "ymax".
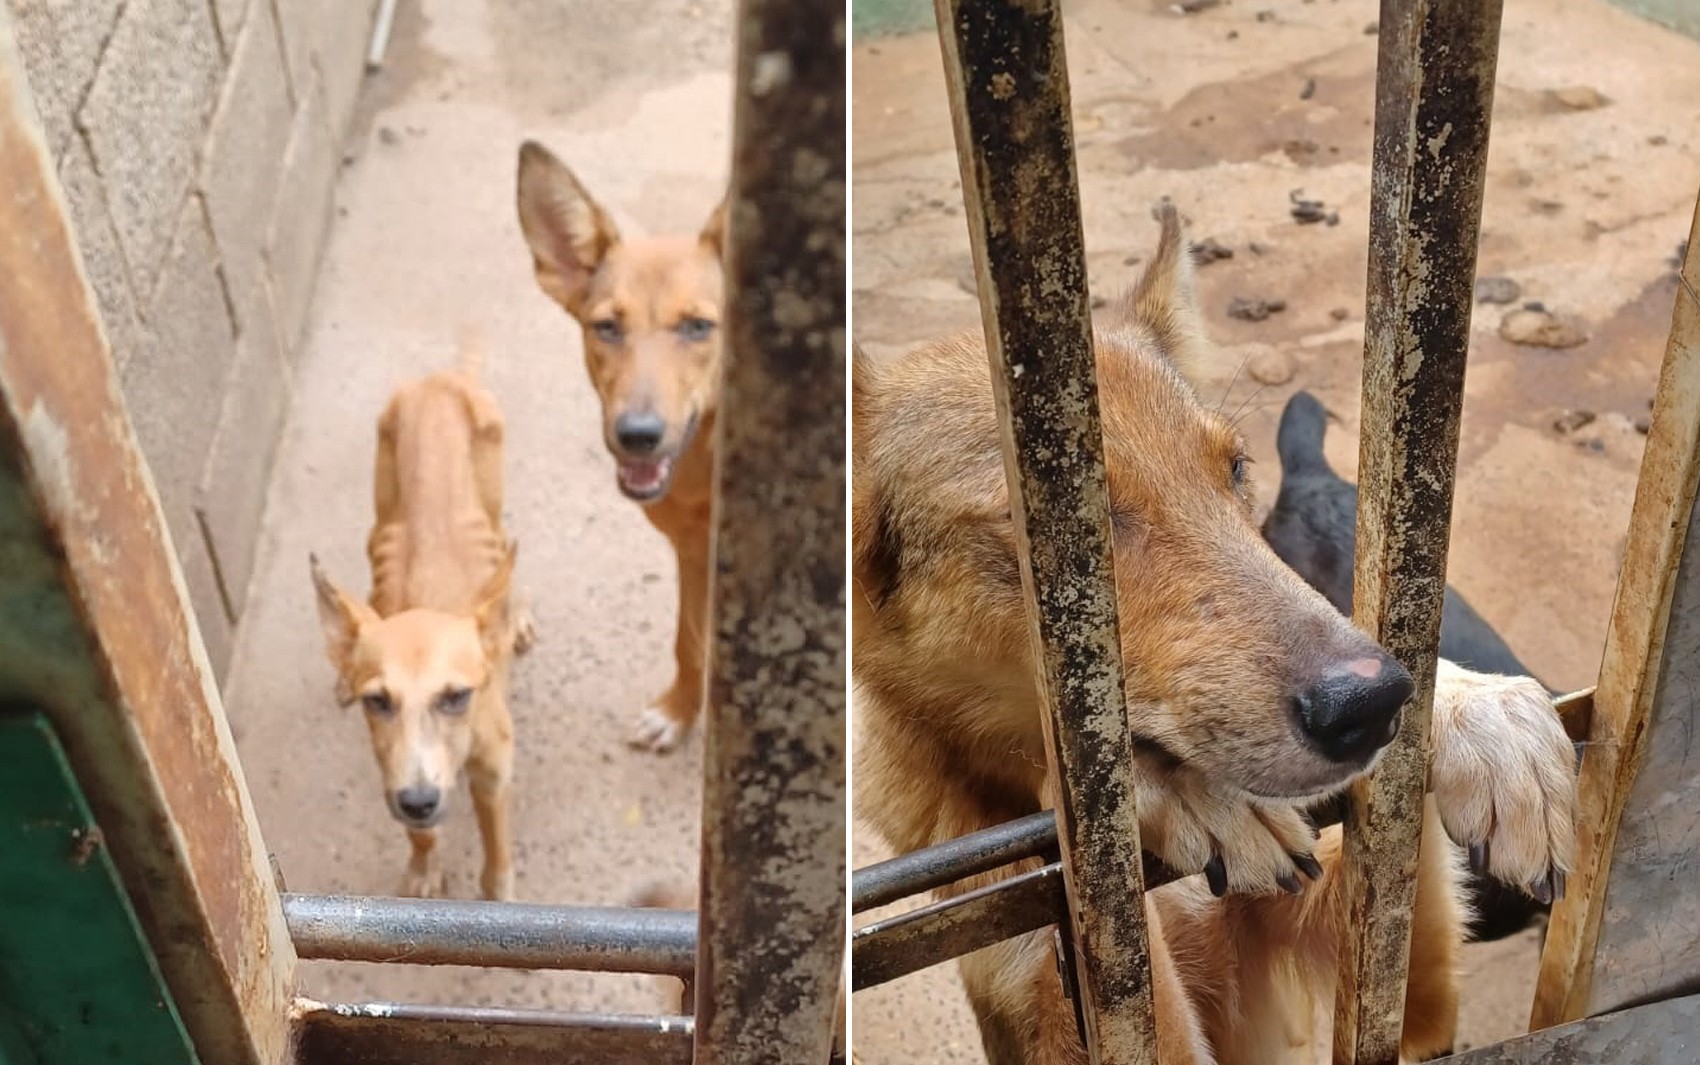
[{"xmin": 695, "ymin": 0, "xmax": 847, "ymax": 1065}]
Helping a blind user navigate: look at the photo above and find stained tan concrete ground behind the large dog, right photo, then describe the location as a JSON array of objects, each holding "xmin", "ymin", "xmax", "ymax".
[{"xmin": 852, "ymin": 0, "xmax": 1700, "ymax": 1065}]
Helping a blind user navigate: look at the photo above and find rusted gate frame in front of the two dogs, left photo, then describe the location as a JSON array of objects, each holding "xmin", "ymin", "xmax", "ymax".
[{"xmin": 0, "ymin": 0, "xmax": 845, "ymax": 1065}]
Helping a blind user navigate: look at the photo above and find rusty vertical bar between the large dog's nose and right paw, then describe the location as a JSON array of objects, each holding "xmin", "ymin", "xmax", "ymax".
[{"xmin": 1335, "ymin": 0, "xmax": 1501, "ymax": 1065}]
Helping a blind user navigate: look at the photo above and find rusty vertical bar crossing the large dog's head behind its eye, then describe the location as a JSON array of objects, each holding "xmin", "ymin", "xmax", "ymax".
[{"xmin": 937, "ymin": 0, "xmax": 1156, "ymax": 1065}]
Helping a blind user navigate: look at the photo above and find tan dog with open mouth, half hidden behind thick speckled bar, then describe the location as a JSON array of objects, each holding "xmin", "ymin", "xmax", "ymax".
[{"xmin": 519, "ymin": 141, "xmax": 726, "ymax": 750}]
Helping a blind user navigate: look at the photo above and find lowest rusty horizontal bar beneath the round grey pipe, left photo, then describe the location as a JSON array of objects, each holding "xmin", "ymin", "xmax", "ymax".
[{"xmin": 292, "ymin": 1000, "xmax": 690, "ymax": 1065}]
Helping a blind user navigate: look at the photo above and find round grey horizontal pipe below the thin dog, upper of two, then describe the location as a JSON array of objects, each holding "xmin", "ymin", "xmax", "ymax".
[{"xmin": 284, "ymin": 895, "xmax": 697, "ymax": 977}]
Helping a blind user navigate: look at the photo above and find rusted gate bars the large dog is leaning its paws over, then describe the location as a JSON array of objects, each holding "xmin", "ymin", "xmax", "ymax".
[{"xmin": 852, "ymin": 0, "xmax": 1700, "ymax": 1065}]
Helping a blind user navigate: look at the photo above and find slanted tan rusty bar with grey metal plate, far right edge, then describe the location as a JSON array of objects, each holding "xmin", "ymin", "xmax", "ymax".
[{"xmin": 1530, "ymin": 188, "xmax": 1700, "ymax": 1028}]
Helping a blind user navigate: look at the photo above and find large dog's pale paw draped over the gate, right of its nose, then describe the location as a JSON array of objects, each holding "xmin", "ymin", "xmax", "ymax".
[{"xmin": 1428, "ymin": 660, "xmax": 1576, "ymax": 902}]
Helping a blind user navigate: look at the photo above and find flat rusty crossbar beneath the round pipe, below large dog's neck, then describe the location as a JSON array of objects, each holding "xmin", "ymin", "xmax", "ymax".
[{"xmin": 850, "ymin": 863, "xmax": 1068, "ymax": 990}]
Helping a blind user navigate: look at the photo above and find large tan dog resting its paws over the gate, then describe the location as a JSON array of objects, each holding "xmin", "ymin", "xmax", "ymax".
[{"xmin": 852, "ymin": 203, "xmax": 1574, "ymax": 1065}]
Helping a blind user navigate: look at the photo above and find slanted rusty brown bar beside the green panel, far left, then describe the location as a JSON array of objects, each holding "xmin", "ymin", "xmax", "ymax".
[{"xmin": 0, "ymin": 16, "xmax": 296, "ymax": 1065}]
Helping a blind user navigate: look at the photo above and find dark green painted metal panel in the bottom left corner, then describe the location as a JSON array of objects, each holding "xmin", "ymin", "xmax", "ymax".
[{"xmin": 0, "ymin": 711, "xmax": 199, "ymax": 1065}]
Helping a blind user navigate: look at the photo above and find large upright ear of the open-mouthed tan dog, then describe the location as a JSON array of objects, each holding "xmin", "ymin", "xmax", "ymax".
[{"xmin": 519, "ymin": 141, "xmax": 621, "ymax": 315}]
